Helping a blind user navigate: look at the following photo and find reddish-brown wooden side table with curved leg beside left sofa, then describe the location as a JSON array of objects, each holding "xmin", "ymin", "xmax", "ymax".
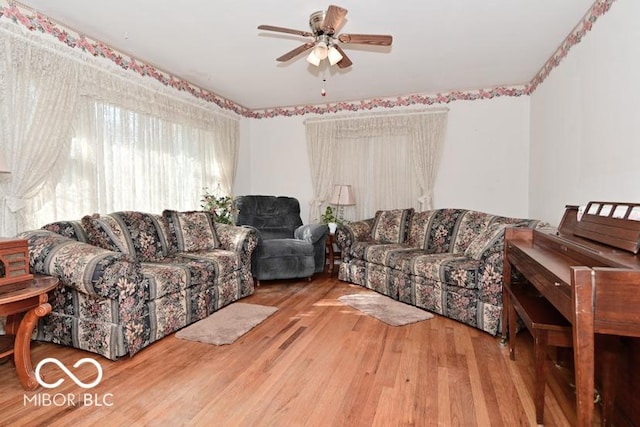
[{"xmin": 0, "ymin": 276, "xmax": 58, "ymax": 390}]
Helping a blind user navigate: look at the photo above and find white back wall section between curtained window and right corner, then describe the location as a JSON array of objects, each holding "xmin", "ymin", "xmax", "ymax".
[{"xmin": 434, "ymin": 96, "xmax": 529, "ymax": 217}]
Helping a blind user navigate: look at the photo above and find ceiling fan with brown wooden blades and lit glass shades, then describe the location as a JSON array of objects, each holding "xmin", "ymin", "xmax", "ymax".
[{"xmin": 258, "ymin": 5, "xmax": 393, "ymax": 68}]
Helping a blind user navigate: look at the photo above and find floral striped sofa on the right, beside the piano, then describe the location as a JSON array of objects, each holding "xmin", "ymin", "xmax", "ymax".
[{"xmin": 336, "ymin": 209, "xmax": 541, "ymax": 335}]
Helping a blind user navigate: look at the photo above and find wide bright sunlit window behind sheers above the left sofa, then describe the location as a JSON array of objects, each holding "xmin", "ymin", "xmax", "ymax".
[{"xmin": 34, "ymin": 101, "xmax": 228, "ymax": 226}]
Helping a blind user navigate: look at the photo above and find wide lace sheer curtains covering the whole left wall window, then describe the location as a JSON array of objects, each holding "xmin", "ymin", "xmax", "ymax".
[{"xmin": 0, "ymin": 22, "xmax": 239, "ymax": 235}]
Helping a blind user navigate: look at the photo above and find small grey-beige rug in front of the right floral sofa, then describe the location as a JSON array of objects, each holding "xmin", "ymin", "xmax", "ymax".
[{"xmin": 338, "ymin": 293, "xmax": 433, "ymax": 326}]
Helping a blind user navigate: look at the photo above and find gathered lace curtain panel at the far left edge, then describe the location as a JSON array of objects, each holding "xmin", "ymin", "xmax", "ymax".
[{"xmin": 0, "ymin": 22, "xmax": 79, "ymax": 236}]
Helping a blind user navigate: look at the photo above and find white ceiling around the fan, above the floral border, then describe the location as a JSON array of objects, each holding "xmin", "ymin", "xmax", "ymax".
[{"xmin": 20, "ymin": 0, "xmax": 594, "ymax": 109}]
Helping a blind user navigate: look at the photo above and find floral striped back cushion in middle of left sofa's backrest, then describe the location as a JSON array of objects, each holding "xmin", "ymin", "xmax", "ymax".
[{"xmin": 82, "ymin": 211, "xmax": 167, "ymax": 262}]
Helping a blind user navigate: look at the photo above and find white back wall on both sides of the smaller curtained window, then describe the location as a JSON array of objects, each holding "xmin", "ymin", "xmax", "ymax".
[{"xmin": 234, "ymin": 97, "xmax": 529, "ymax": 223}]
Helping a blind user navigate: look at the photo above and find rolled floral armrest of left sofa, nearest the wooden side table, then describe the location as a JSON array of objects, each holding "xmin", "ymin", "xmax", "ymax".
[{"xmin": 18, "ymin": 230, "xmax": 149, "ymax": 301}]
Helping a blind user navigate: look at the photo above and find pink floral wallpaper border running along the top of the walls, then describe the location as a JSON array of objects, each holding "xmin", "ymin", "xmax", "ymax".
[{"xmin": 0, "ymin": 0, "xmax": 616, "ymax": 119}]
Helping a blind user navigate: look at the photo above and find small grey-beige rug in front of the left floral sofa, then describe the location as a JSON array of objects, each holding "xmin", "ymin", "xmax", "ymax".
[{"xmin": 176, "ymin": 302, "xmax": 278, "ymax": 345}]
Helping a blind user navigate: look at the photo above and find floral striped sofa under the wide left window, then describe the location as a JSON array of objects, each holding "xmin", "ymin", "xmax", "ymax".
[{"xmin": 19, "ymin": 210, "xmax": 258, "ymax": 360}]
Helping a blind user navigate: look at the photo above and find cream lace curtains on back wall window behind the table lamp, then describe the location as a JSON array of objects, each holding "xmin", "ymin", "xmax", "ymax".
[{"xmin": 305, "ymin": 110, "xmax": 448, "ymax": 221}]
